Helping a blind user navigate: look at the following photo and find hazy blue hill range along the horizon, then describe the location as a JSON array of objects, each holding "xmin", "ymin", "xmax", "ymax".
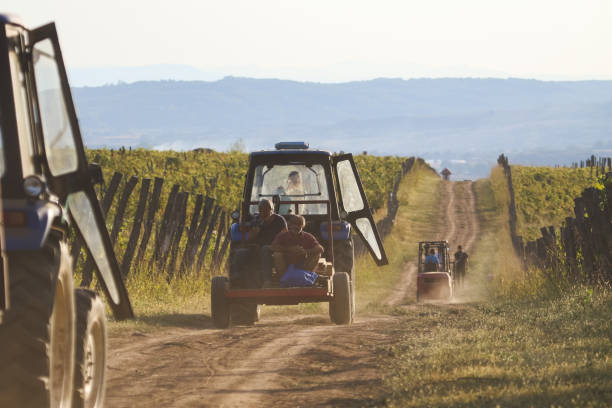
[{"xmin": 73, "ymin": 77, "xmax": 612, "ymax": 177}]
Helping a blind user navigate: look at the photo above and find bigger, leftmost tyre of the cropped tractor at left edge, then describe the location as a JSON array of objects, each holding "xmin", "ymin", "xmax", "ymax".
[{"xmin": 0, "ymin": 241, "xmax": 75, "ymax": 407}]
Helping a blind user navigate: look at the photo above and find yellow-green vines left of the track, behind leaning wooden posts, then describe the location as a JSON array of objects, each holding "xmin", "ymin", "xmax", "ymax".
[{"xmin": 81, "ymin": 150, "xmax": 405, "ymax": 297}]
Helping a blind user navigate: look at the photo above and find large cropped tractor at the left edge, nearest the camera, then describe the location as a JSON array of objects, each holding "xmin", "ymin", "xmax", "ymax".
[{"xmin": 0, "ymin": 15, "xmax": 133, "ymax": 408}]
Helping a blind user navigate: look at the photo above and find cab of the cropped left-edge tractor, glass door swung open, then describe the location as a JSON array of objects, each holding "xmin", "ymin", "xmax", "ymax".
[{"xmin": 0, "ymin": 15, "xmax": 133, "ymax": 319}]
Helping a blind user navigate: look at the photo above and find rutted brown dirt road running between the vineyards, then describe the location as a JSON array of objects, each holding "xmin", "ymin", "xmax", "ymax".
[{"xmin": 106, "ymin": 182, "xmax": 478, "ymax": 407}]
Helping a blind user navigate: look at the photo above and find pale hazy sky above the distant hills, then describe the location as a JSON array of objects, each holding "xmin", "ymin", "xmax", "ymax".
[{"xmin": 0, "ymin": 0, "xmax": 612, "ymax": 82}]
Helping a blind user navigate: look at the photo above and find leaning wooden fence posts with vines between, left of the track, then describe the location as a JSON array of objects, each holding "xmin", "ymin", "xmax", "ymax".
[{"xmin": 72, "ymin": 153, "xmax": 415, "ymax": 287}]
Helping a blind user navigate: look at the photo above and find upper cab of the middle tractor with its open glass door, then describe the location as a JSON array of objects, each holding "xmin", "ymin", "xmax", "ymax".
[{"xmin": 241, "ymin": 142, "xmax": 388, "ymax": 264}]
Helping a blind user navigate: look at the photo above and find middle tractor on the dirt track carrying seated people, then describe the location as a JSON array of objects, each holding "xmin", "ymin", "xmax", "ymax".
[{"xmin": 211, "ymin": 142, "xmax": 388, "ymax": 328}]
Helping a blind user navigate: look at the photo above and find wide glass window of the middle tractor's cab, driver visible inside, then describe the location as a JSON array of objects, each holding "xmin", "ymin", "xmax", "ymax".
[{"xmin": 250, "ymin": 164, "xmax": 329, "ymax": 214}]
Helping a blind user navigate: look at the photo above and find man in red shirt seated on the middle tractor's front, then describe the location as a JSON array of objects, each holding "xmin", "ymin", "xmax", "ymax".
[{"xmin": 270, "ymin": 214, "xmax": 324, "ymax": 276}]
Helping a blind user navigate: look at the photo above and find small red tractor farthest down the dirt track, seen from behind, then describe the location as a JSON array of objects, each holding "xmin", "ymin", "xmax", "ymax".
[{"xmin": 417, "ymin": 241, "xmax": 453, "ymax": 302}]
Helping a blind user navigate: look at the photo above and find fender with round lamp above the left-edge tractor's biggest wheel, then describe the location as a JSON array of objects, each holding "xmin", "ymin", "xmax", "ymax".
[{"xmin": 2, "ymin": 199, "xmax": 62, "ymax": 251}]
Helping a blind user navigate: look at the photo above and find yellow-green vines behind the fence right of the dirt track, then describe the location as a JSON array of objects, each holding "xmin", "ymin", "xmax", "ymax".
[{"xmin": 512, "ymin": 166, "xmax": 597, "ymax": 241}]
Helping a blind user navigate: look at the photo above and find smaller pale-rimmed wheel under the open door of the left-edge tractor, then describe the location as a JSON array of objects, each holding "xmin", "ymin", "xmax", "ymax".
[{"xmin": 72, "ymin": 288, "xmax": 106, "ymax": 408}]
